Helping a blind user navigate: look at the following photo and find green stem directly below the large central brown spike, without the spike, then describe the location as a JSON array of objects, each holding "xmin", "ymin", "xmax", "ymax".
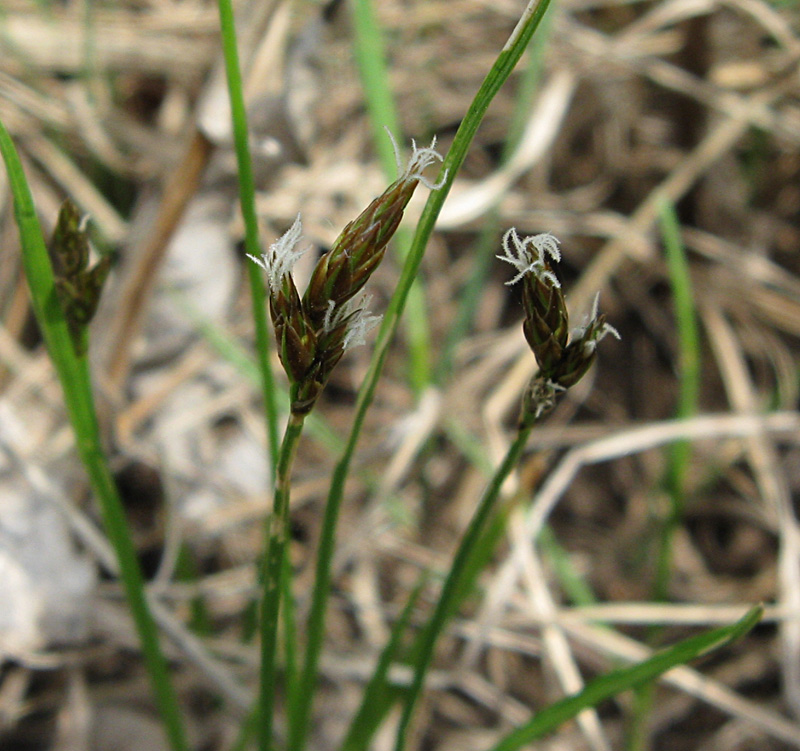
[{"xmin": 258, "ymin": 414, "xmax": 303, "ymax": 751}]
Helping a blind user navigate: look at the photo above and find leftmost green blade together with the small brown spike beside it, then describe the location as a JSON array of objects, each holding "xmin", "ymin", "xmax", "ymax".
[{"xmin": 0, "ymin": 123, "xmax": 188, "ymax": 751}]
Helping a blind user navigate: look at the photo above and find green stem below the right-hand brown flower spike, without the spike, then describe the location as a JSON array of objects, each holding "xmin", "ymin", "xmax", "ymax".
[{"xmin": 395, "ymin": 427, "xmax": 532, "ymax": 751}]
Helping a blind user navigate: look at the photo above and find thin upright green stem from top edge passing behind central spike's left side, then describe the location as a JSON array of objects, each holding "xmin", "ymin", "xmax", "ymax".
[{"xmin": 219, "ymin": 0, "xmax": 278, "ymax": 477}]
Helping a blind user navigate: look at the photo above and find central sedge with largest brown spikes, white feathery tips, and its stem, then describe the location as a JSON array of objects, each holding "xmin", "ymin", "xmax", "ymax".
[{"xmin": 249, "ymin": 139, "xmax": 442, "ymax": 750}]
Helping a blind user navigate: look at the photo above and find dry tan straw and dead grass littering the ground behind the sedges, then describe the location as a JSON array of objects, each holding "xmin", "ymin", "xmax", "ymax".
[{"xmin": 0, "ymin": 0, "xmax": 800, "ymax": 751}]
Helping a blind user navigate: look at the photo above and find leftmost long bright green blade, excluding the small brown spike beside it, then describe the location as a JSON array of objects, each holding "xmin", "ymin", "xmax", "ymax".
[{"xmin": 0, "ymin": 123, "xmax": 188, "ymax": 751}]
